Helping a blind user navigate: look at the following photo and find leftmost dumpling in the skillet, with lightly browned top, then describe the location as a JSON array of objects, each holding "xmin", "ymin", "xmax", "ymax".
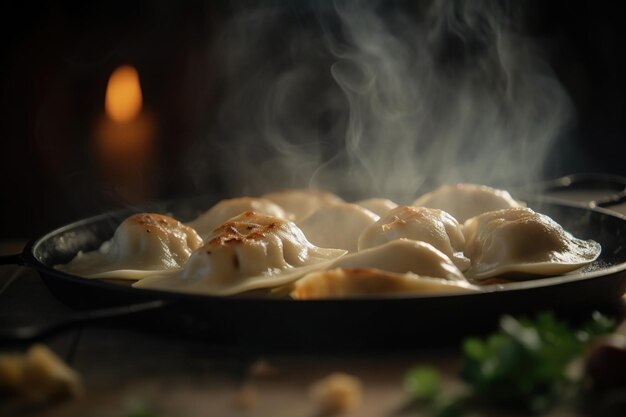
[{"xmin": 57, "ymin": 213, "xmax": 202, "ymax": 279}]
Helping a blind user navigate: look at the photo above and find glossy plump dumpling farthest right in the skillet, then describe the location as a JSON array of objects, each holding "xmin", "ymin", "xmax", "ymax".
[{"xmin": 463, "ymin": 208, "xmax": 601, "ymax": 280}]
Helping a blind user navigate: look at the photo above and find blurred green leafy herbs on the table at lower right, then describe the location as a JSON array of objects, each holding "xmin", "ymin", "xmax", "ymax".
[{"xmin": 405, "ymin": 312, "xmax": 615, "ymax": 416}]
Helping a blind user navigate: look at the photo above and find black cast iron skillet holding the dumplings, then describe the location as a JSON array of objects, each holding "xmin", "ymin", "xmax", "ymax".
[{"xmin": 0, "ymin": 172, "xmax": 626, "ymax": 349}]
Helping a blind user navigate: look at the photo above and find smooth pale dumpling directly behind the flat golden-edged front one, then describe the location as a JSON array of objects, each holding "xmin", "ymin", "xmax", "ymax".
[{"xmin": 332, "ymin": 239, "xmax": 465, "ymax": 281}]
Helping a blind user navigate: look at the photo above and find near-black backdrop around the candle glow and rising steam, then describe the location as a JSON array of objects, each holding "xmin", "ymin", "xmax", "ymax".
[{"xmin": 0, "ymin": 0, "xmax": 626, "ymax": 238}]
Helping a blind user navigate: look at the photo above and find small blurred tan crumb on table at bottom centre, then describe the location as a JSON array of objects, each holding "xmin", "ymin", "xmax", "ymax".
[{"xmin": 310, "ymin": 372, "xmax": 363, "ymax": 414}]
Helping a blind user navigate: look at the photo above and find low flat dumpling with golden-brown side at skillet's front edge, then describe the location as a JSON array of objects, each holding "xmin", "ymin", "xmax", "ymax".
[{"xmin": 290, "ymin": 268, "xmax": 478, "ymax": 300}]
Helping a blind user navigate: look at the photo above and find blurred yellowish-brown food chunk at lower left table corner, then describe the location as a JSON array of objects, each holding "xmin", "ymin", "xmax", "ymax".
[{"xmin": 0, "ymin": 344, "xmax": 82, "ymax": 403}]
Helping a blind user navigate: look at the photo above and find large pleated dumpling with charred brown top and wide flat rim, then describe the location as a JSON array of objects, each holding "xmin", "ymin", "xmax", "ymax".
[{"xmin": 133, "ymin": 211, "xmax": 346, "ymax": 295}]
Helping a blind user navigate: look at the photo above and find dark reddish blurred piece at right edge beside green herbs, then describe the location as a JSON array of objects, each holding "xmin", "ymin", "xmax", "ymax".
[{"xmin": 585, "ymin": 333, "xmax": 626, "ymax": 392}]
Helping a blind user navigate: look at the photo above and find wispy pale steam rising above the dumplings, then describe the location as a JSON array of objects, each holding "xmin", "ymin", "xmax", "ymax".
[{"xmin": 191, "ymin": 0, "xmax": 570, "ymax": 202}]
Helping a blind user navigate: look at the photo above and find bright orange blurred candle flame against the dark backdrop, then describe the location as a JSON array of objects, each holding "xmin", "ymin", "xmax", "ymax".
[{"xmin": 104, "ymin": 65, "xmax": 143, "ymax": 123}]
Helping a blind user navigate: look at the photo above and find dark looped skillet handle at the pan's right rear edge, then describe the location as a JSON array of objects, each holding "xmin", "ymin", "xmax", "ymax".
[{"xmin": 540, "ymin": 173, "xmax": 626, "ymax": 207}]
